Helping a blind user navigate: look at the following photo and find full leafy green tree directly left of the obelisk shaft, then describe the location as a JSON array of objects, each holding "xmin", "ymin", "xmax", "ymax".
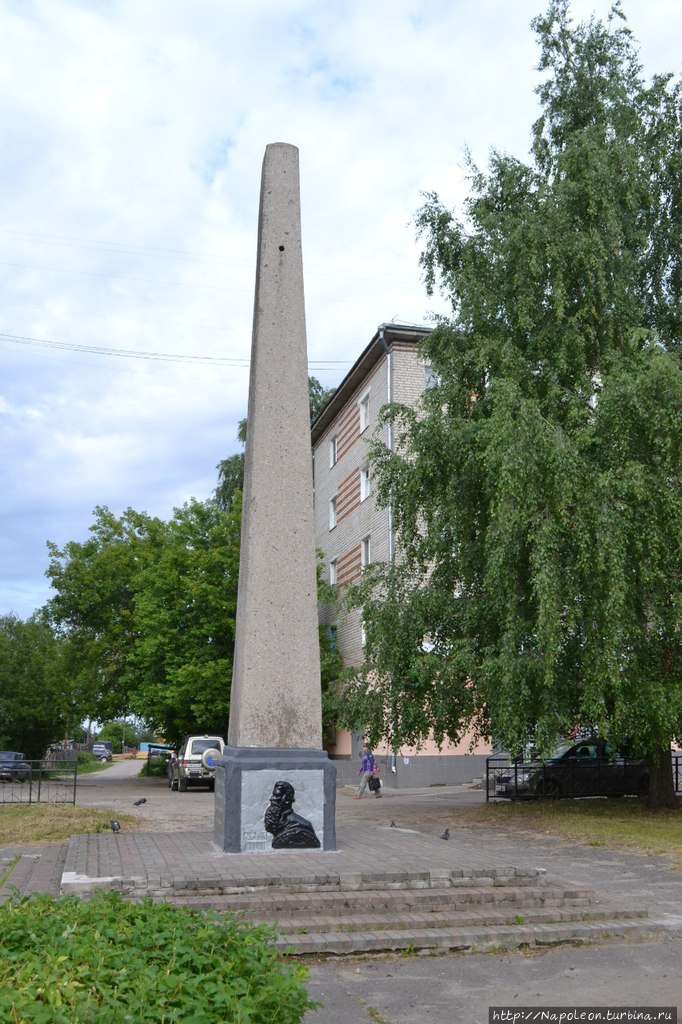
[{"xmin": 47, "ymin": 501, "xmax": 241, "ymax": 738}]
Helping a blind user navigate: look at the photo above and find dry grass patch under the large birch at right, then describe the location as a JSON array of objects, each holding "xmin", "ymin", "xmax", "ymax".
[{"xmin": 450, "ymin": 799, "xmax": 682, "ymax": 870}]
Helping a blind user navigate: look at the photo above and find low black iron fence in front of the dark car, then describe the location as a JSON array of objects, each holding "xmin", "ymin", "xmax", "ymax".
[{"xmin": 485, "ymin": 754, "xmax": 682, "ymax": 801}]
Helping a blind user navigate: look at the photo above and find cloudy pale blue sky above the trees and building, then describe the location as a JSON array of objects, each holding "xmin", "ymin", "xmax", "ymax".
[{"xmin": 0, "ymin": 0, "xmax": 682, "ymax": 617}]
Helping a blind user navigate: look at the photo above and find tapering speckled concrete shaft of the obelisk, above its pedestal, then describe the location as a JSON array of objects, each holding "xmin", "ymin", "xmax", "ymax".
[{"xmin": 228, "ymin": 142, "xmax": 322, "ymax": 750}]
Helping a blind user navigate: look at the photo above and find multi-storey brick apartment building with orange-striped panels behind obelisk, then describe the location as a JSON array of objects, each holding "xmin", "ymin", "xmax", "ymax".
[{"xmin": 312, "ymin": 324, "xmax": 487, "ymax": 787}]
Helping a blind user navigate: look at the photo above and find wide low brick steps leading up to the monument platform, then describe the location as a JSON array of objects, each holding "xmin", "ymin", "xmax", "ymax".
[{"xmin": 146, "ymin": 868, "xmax": 652, "ymax": 956}]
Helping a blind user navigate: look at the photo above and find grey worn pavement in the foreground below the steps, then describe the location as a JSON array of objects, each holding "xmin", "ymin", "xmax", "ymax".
[{"xmin": 304, "ymin": 935, "xmax": 682, "ymax": 1024}]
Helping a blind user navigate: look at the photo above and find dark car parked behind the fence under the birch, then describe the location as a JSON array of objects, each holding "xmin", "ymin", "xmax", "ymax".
[{"xmin": 495, "ymin": 738, "xmax": 649, "ymax": 800}]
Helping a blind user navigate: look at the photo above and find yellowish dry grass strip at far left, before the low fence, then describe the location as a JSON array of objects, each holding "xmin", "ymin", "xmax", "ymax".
[{"xmin": 0, "ymin": 804, "xmax": 139, "ymax": 846}]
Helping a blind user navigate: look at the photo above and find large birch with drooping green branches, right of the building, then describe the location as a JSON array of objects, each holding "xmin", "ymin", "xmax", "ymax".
[{"xmin": 344, "ymin": 0, "xmax": 682, "ymax": 806}]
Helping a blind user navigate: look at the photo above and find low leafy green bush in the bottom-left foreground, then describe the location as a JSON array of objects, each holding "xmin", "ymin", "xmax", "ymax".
[{"xmin": 0, "ymin": 893, "xmax": 316, "ymax": 1024}]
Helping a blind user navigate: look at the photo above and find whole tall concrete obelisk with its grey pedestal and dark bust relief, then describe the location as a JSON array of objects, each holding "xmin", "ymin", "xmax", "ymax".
[{"xmin": 214, "ymin": 142, "xmax": 336, "ymax": 852}]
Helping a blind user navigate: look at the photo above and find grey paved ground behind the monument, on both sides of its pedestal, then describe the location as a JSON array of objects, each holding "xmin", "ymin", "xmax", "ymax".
[{"xmin": 76, "ymin": 760, "xmax": 484, "ymax": 835}]
